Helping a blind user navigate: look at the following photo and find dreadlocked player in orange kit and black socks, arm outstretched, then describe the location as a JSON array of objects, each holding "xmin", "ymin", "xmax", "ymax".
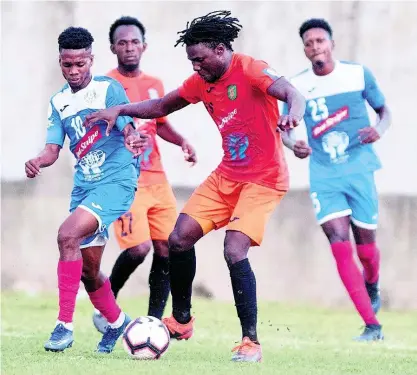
[{"xmin": 84, "ymin": 11, "xmax": 305, "ymax": 362}]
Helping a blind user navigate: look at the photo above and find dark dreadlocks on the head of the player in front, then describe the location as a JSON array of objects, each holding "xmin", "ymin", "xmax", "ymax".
[{"xmin": 174, "ymin": 10, "xmax": 242, "ymax": 51}]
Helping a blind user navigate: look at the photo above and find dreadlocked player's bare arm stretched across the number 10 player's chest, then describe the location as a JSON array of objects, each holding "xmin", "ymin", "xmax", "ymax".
[{"xmin": 84, "ymin": 90, "xmax": 190, "ymax": 134}]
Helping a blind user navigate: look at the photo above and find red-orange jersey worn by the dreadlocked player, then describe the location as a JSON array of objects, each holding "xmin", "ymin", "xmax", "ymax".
[{"xmin": 179, "ymin": 53, "xmax": 289, "ymax": 190}]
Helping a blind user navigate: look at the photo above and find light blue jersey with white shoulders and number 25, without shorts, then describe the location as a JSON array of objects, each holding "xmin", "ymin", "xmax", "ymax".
[{"xmin": 284, "ymin": 61, "xmax": 385, "ymax": 180}]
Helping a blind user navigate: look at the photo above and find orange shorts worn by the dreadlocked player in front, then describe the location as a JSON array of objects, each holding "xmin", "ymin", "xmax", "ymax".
[{"xmin": 182, "ymin": 172, "xmax": 286, "ymax": 246}]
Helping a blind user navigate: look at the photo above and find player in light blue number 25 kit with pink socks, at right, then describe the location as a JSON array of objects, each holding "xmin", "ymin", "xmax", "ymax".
[{"xmin": 283, "ymin": 19, "xmax": 391, "ymax": 341}]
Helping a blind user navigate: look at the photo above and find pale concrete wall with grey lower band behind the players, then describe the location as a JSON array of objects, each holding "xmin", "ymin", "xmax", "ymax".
[{"xmin": 1, "ymin": 2, "xmax": 417, "ymax": 308}]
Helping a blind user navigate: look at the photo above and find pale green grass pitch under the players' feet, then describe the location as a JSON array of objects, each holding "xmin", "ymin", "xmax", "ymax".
[{"xmin": 1, "ymin": 293, "xmax": 417, "ymax": 375}]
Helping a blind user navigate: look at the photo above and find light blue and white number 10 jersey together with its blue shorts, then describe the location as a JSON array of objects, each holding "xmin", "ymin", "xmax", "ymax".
[{"xmin": 46, "ymin": 77, "xmax": 138, "ymax": 248}]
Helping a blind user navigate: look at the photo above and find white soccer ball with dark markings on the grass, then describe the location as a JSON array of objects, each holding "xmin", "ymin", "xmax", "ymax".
[{"xmin": 122, "ymin": 316, "xmax": 170, "ymax": 359}]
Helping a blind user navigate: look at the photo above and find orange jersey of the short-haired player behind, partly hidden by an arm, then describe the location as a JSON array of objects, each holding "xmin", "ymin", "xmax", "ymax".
[{"xmin": 107, "ymin": 69, "xmax": 167, "ymax": 186}]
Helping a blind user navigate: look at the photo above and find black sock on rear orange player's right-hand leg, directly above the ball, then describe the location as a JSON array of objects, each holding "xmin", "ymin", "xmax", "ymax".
[{"xmin": 148, "ymin": 253, "xmax": 170, "ymax": 319}]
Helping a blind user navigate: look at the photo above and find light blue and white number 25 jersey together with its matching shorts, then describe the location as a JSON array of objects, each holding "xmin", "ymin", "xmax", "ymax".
[{"xmin": 283, "ymin": 61, "xmax": 385, "ymax": 229}]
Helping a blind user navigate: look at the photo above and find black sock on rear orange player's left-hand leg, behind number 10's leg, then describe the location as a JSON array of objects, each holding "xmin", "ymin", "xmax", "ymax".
[{"xmin": 109, "ymin": 250, "xmax": 145, "ymax": 298}]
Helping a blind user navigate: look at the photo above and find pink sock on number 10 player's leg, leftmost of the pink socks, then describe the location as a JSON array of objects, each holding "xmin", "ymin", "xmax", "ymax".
[{"xmin": 58, "ymin": 259, "xmax": 83, "ymax": 323}]
